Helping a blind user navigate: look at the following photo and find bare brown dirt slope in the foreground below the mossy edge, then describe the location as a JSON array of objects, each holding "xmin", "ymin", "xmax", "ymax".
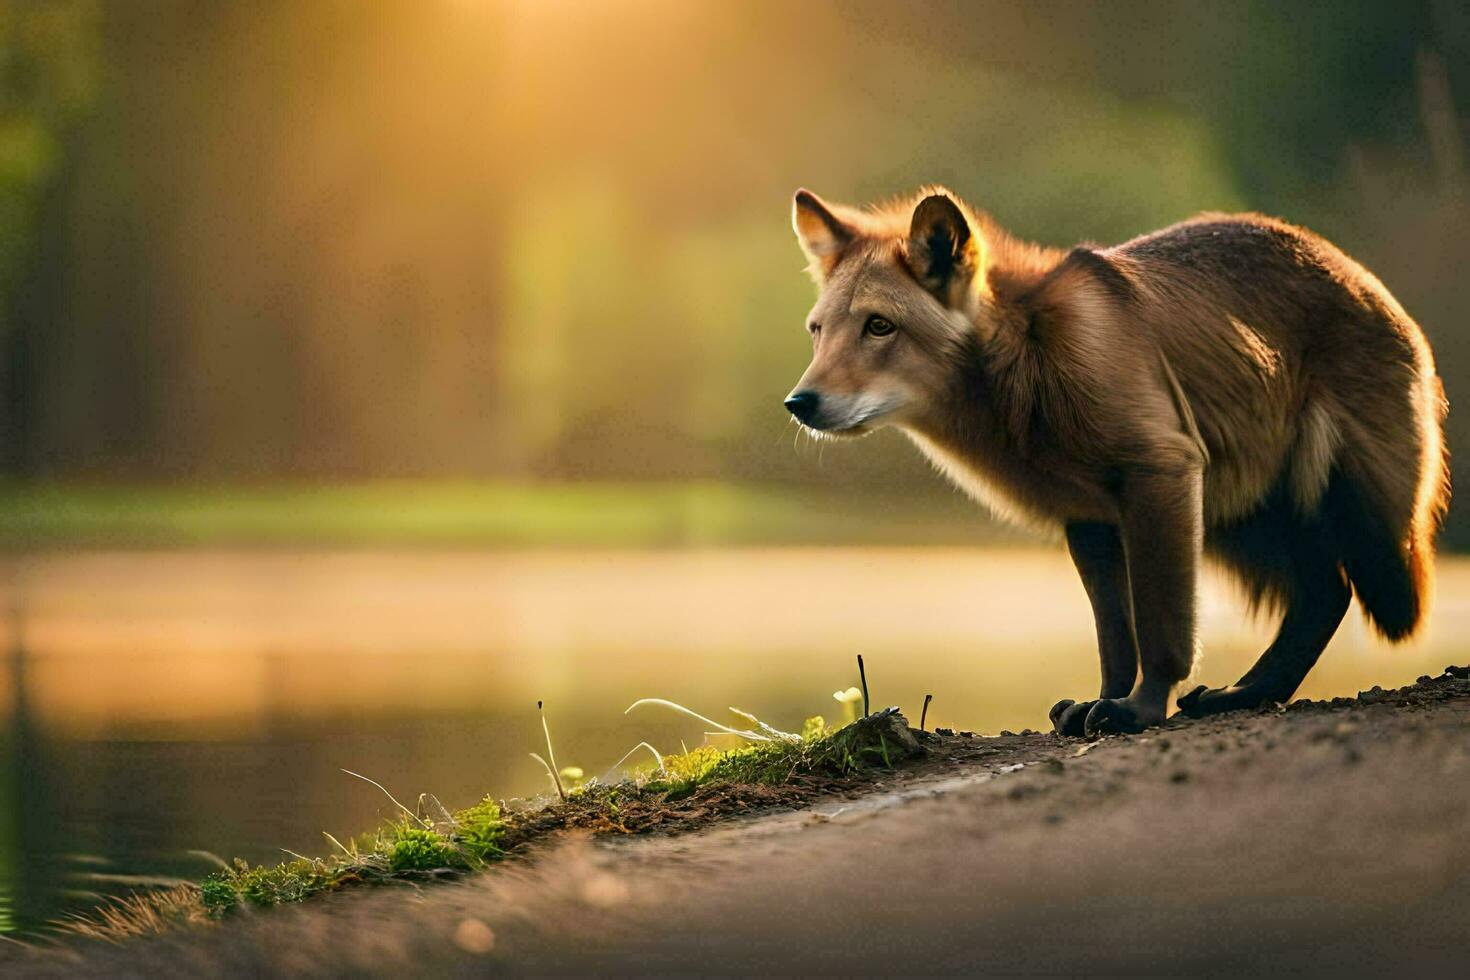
[{"xmin": 11, "ymin": 669, "xmax": 1470, "ymax": 977}]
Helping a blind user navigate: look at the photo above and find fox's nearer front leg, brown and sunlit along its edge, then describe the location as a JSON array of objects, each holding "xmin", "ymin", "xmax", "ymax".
[{"xmin": 1083, "ymin": 467, "xmax": 1204, "ymax": 736}]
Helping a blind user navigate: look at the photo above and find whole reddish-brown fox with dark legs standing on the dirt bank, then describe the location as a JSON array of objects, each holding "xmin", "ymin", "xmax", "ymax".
[{"xmin": 785, "ymin": 187, "xmax": 1449, "ymax": 738}]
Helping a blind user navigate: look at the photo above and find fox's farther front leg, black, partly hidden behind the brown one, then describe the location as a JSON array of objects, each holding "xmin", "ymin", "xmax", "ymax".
[{"xmin": 1051, "ymin": 522, "xmax": 1138, "ymax": 736}]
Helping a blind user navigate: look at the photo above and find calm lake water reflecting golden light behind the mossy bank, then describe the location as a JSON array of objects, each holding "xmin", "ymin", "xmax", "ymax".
[{"xmin": 0, "ymin": 548, "xmax": 1470, "ymax": 933}]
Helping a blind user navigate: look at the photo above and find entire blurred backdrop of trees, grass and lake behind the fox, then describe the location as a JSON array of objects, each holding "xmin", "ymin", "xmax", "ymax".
[{"xmin": 0, "ymin": 0, "xmax": 1470, "ymax": 932}]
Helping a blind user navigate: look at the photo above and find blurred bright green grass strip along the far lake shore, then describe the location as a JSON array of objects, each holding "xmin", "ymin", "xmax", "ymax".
[{"xmin": 0, "ymin": 480, "xmax": 1017, "ymax": 550}]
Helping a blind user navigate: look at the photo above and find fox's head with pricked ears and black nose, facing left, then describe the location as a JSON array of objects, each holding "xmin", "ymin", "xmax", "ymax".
[{"xmin": 785, "ymin": 188, "xmax": 989, "ymax": 436}]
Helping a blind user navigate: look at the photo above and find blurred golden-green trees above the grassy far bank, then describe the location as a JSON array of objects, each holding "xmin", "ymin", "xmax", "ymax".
[{"xmin": 0, "ymin": 0, "xmax": 1470, "ymax": 541}]
